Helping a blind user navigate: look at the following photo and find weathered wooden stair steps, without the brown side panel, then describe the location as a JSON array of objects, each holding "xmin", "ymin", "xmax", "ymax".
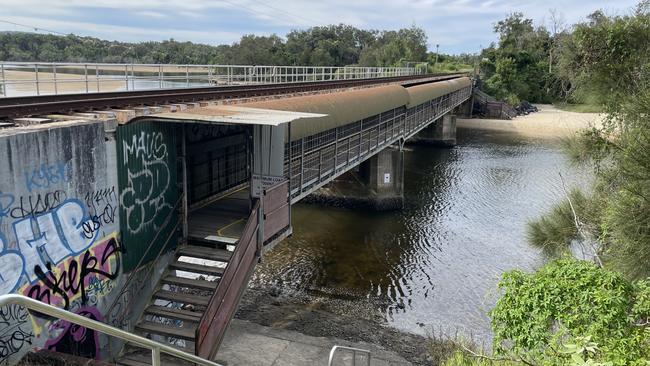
[{"xmin": 117, "ymin": 238, "xmax": 233, "ymax": 366}]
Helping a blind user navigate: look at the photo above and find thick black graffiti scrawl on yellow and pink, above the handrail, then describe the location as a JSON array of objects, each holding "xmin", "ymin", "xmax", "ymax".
[{"xmin": 25, "ymin": 238, "xmax": 121, "ymax": 309}]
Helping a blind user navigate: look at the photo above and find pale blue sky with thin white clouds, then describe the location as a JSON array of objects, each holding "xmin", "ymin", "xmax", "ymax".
[{"xmin": 0, "ymin": 0, "xmax": 639, "ymax": 54}]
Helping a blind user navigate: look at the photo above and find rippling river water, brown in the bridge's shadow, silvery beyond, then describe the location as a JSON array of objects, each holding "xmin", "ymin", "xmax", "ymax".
[{"xmin": 247, "ymin": 130, "xmax": 589, "ymax": 341}]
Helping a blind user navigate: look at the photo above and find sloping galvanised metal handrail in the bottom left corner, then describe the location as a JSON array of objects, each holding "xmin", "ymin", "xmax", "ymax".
[{"xmin": 0, "ymin": 294, "xmax": 222, "ymax": 366}]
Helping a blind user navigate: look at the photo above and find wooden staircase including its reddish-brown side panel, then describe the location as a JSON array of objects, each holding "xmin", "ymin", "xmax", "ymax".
[{"xmin": 116, "ymin": 180, "xmax": 291, "ymax": 366}]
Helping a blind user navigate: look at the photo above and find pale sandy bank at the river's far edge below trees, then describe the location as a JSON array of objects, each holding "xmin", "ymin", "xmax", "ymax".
[{"xmin": 457, "ymin": 105, "xmax": 604, "ymax": 138}]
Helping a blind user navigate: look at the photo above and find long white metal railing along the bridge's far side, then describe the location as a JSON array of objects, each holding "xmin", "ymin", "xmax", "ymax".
[{"xmin": 0, "ymin": 61, "xmax": 426, "ymax": 97}]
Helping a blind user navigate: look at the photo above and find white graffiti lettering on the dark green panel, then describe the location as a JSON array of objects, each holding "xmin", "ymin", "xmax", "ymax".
[{"xmin": 120, "ymin": 132, "xmax": 172, "ymax": 234}]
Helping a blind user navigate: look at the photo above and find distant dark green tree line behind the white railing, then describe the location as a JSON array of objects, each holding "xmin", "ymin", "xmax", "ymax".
[{"xmin": 0, "ymin": 24, "xmax": 446, "ymax": 66}]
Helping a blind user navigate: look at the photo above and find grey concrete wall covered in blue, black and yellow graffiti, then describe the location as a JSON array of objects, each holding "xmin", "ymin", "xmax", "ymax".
[{"xmin": 0, "ymin": 122, "xmax": 126, "ymax": 365}]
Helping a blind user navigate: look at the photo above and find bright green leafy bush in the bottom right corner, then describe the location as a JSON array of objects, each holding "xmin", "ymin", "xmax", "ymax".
[{"xmin": 490, "ymin": 259, "xmax": 650, "ymax": 365}]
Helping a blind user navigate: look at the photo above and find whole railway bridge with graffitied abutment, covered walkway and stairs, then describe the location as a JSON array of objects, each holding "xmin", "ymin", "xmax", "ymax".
[{"xmin": 0, "ymin": 63, "xmax": 472, "ymax": 366}]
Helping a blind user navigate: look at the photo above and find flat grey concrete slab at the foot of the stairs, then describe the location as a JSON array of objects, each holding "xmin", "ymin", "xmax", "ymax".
[{"xmin": 216, "ymin": 319, "xmax": 411, "ymax": 366}]
